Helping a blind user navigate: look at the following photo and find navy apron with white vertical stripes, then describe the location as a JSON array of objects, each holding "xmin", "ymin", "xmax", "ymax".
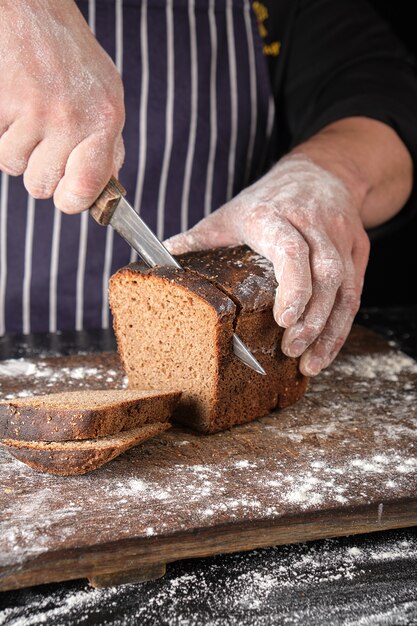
[{"xmin": 0, "ymin": 0, "xmax": 274, "ymax": 335}]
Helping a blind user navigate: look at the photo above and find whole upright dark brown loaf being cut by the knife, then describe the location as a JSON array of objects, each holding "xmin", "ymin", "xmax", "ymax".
[{"xmin": 110, "ymin": 246, "xmax": 307, "ymax": 433}]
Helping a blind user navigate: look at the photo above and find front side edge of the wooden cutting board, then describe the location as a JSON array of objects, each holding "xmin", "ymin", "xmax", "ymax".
[{"xmin": 0, "ymin": 499, "xmax": 417, "ymax": 591}]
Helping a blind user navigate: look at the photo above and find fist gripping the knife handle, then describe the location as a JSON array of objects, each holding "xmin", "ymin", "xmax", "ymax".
[{"xmin": 0, "ymin": 0, "xmax": 124, "ymax": 213}]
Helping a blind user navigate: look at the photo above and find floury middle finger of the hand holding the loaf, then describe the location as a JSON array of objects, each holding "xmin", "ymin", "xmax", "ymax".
[{"xmin": 281, "ymin": 233, "xmax": 344, "ymax": 357}]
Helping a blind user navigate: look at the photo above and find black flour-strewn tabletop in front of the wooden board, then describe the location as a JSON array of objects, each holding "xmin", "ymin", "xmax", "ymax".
[{"xmin": 0, "ymin": 527, "xmax": 417, "ymax": 626}]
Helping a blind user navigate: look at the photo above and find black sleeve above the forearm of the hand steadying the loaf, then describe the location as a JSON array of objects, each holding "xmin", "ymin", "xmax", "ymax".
[{"xmin": 277, "ymin": 0, "xmax": 417, "ymax": 233}]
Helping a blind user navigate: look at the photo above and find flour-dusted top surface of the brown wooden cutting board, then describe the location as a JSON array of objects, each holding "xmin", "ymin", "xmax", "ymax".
[{"xmin": 0, "ymin": 336, "xmax": 417, "ymax": 610}]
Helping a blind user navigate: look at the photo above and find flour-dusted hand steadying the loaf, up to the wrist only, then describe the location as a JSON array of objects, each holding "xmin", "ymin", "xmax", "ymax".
[{"xmin": 166, "ymin": 155, "xmax": 369, "ymax": 375}]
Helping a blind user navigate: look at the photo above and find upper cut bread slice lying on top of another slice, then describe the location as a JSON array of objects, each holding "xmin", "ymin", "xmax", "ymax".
[{"xmin": 0, "ymin": 389, "xmax": 181, "ymax": 441}]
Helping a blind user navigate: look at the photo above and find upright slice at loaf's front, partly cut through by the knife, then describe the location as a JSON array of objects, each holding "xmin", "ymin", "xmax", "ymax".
[{"xmin": 109, "ymin": 265, "xmax": 236, "ymax": 432}]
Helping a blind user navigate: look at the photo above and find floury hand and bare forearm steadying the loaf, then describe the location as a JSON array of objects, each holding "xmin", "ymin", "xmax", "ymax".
[{"xmin": 167, "ymin": 117, "xmax": 413, "ymax": 376}]
